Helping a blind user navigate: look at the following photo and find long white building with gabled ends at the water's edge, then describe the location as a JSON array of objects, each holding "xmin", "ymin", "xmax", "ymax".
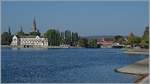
[{"xmin": 11, "ymin": 35, "xmax": 48, "ymax": 47}]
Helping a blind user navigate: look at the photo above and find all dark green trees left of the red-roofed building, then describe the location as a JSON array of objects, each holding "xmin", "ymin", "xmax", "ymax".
[{"xmin": 1, "ymin": 27, "xmax": 100, "ymax": 48}]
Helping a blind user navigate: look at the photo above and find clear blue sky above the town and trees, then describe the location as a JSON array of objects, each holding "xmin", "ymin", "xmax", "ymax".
[{"xmin": 1, "ymin": 1, "xmax": 148, "ymax": 36}]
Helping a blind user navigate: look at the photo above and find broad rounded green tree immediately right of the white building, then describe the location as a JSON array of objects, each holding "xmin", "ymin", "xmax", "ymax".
[{"xmin": 44, "ymin": 29, "xmax": 61, "ymax": 46}]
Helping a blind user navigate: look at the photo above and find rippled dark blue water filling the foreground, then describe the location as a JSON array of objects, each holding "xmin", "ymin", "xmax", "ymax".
[{"xmin": 1, "ymin": 48, "xmax": 145, "ymax": 83}]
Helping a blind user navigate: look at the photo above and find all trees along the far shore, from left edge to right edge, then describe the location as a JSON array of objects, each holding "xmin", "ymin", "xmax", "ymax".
[{"xmin": 1, "ymin": 27, "xmax": 149, "ymax": 48}]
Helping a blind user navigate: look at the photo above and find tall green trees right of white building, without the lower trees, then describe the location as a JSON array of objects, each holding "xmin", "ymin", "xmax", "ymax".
[{"xmin": 44, "ymin": 29, "xmax": 80, "ymax": 46}]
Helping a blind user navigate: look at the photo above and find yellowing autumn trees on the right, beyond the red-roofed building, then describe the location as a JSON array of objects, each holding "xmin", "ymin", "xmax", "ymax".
[{"xmin": 114, "ymin": 26, "xmax": 149, "ymax": 48}]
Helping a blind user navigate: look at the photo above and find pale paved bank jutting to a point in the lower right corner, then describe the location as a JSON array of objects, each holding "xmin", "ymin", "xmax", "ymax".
[{"xmin": 114, "ymin": 58, "xmax": 149, "ymax": 83}]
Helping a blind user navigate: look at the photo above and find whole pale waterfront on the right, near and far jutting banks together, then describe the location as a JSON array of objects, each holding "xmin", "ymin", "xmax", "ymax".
[{"xmin": 116, "ymin": 49, "xmax": 149, "ymax": 84}]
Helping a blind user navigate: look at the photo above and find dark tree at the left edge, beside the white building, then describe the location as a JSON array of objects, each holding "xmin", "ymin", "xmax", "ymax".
[{"xmin": 1, "ymin": 32, "xmax": 12, "ymax": 45}]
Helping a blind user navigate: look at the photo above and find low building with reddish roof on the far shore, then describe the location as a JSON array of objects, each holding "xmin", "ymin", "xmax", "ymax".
[{"xmin": 97, "ymin": 38, "xmax": 113, "ymax": 48}]
